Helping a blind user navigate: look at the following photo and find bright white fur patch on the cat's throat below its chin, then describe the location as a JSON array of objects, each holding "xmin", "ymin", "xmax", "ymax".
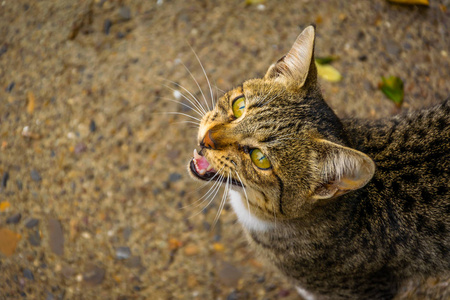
[{"xmin": 230, "ymin": 190, "xmax": 274, "ymax": 231}]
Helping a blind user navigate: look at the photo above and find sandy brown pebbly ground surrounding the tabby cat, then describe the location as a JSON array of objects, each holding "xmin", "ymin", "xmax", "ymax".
[{"xmin": 0, "ymin": 0, "xmax": 450, "ymax": 300}]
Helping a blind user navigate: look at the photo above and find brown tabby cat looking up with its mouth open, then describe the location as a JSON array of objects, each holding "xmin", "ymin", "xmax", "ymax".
[{"xmin": 188, "ymin": 26, "xmax": 450, "ymax": 299}]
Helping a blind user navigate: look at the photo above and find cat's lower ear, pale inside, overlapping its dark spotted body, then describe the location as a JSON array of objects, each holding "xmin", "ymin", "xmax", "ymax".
[{"xmin": 312, "ymin": 140, "xmax": 375, "ymax": 199}]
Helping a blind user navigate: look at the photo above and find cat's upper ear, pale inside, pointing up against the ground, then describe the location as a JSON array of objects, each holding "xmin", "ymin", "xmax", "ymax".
[{"xmin": 264, "ymin": 25, "xmax": 317, "ymax": 86}]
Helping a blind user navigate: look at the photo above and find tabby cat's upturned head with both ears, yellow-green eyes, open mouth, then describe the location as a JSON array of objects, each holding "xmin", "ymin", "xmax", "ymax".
[{"xmin": 188, "ymin": 26, "xmax": 375, "ymax": 220}]
